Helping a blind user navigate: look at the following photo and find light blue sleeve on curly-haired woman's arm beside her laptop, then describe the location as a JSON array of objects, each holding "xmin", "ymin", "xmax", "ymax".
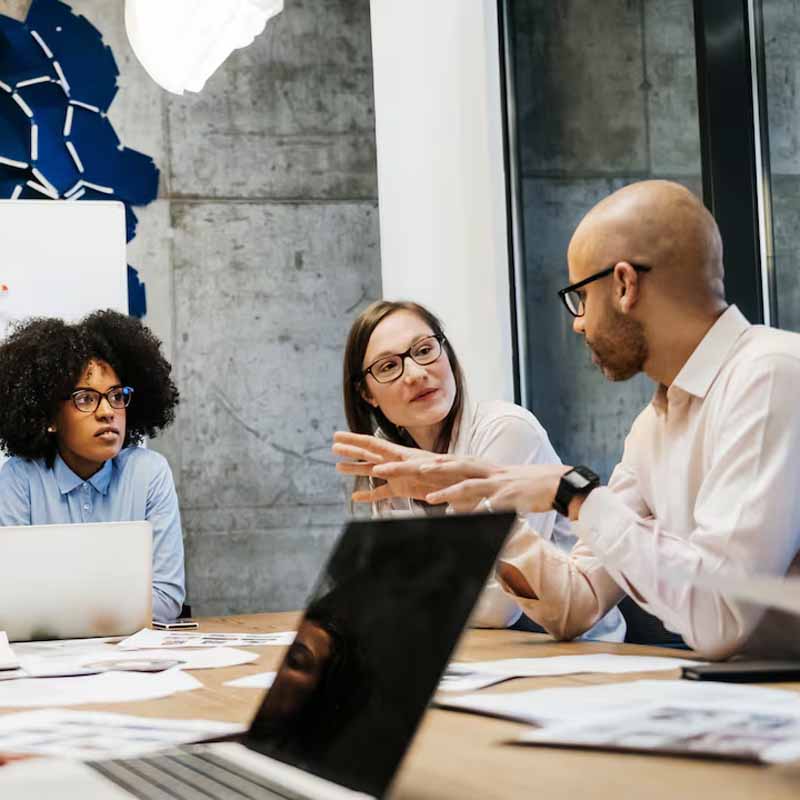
[{"xmin": 145, "ymin": 460, "xmax": 186, "ymax": 622}]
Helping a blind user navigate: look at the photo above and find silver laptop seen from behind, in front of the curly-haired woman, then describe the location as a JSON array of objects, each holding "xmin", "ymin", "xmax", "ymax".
[{"xmin": 0, "ymin": 522, "xmax": 153, "ymax": 642}]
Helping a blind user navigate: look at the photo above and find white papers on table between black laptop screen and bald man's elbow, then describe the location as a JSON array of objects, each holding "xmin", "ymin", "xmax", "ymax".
[{"xmin": 439, "ymin": 653, "xmax": 701, "ymax": 692}]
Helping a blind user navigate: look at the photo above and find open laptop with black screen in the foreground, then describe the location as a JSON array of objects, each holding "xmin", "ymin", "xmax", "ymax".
[{"xmin": 57, "ymin": 514, "xmax": 515, "ymax": 800}]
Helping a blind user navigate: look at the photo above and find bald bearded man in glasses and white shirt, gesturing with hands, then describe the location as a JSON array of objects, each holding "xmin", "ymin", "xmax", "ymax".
[{"xmin": 337, "ymin": 181, "xmax": 800, "ymax": 659}]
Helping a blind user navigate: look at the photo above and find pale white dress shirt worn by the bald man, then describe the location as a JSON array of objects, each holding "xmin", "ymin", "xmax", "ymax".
[{"xmin": 502, "ymin": 306, "xmax": 800, "ymax": 658}]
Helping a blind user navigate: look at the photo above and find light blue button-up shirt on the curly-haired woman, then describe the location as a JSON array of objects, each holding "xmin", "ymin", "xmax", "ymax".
[{"xmin": 0, "ymin": 447, "xmax": 186, "ymax": 621}]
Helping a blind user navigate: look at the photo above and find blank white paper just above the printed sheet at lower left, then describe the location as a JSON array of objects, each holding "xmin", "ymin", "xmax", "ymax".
[{"xmin": 0, "ymin": 669, "xmax": 203, "ymax": 708}]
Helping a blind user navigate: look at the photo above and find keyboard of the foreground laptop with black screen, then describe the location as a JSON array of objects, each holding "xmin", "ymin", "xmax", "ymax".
[{"xmin": 88, "ymin": 749, "xmax": 300, "ymax": 800}]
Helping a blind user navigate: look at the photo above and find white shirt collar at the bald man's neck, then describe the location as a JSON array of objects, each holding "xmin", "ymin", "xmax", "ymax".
[{"xmin": 653, "ymin": 306, "xmax": 750, "ymax": 411}]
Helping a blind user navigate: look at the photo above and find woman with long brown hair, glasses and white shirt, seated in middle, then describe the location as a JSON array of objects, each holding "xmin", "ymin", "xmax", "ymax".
[{"xmin": 333, "ymin": 300, "xmax": 625, "ymax": 641}]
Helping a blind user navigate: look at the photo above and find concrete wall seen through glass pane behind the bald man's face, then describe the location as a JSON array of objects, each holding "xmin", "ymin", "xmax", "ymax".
[{"xmin": 511, "ymin": 0, "xmax": 701, "ymax": 477}]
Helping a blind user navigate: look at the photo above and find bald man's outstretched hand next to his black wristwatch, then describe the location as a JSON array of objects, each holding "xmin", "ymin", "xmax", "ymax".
[{"xmin": 420, "ymin": 459, "xmax": 571, "ymax": 514}]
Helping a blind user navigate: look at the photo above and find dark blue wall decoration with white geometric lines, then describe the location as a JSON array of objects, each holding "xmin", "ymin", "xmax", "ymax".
[{"xmin": 0, "ymin": 0, "xmax": 159, "ymax": 316}]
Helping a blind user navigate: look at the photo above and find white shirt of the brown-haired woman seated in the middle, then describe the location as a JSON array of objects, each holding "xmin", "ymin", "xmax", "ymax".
[{"xmin": 373, "ymin": 400, "xmax": 625, "ymax": 642}]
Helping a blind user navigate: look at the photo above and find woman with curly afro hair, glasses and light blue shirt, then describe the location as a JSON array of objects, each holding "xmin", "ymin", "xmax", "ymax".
[{"xmin": 0, "ymin": 311, "xmax": 185, "ymax": 621}]
